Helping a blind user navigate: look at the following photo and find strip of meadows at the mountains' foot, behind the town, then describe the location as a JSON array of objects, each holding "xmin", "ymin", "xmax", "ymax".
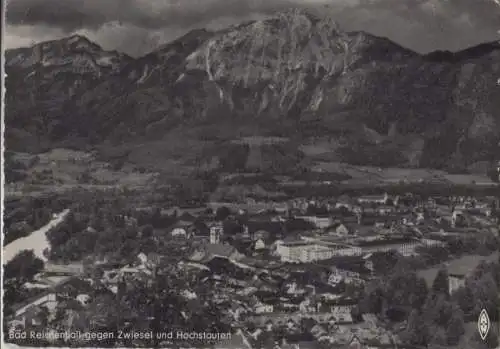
[{"xmin": 6, "ymin": 141, "xmax": 494, "ymax": 201}]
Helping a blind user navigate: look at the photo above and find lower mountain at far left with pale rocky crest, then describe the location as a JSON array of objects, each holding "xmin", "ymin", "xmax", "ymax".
[{"xmin": 5, "ymin": 35, "xmax": 132, "ymax": 150}]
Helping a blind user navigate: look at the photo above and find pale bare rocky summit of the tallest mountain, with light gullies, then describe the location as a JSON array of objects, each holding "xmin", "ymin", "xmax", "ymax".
[{"xmin": 180, "ymin": 9, "xmax": 417, "ymax": 115}]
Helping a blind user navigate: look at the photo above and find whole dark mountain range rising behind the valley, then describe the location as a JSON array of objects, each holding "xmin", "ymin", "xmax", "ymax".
[{"xmin": 5, "ymin": 10, "xmax": 500, "ymax": 177}]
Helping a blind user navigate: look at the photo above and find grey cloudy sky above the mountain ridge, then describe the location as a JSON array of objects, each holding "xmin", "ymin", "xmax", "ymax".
[{"xmin": 4, "ymin": 0, "xmax": 500, "ymax": 56}]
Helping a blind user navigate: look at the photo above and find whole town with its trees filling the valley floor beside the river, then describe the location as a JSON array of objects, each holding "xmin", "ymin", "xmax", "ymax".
[{"xmin": 4, "ymin": 181, "xmax": 500, "ymax": 349}]
